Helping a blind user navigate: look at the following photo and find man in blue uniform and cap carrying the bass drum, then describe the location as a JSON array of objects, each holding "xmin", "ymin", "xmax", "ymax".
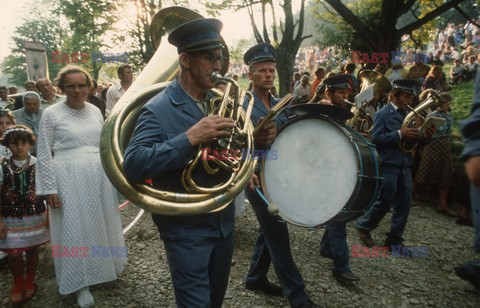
[{"xmin": 244, "ymin": 43, "xmax": 318, "ymax": 308}]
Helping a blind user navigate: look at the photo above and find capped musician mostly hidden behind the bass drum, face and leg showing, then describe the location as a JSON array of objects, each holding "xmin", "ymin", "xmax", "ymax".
[{"xmin": 320, "ymin": 74, "xmax": 360, "ymax": 283}]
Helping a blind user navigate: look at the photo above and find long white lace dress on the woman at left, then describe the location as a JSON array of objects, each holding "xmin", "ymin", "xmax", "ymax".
[{"xmin": 36, "ymin": 102, "xmax": 127, "ymax": 294}]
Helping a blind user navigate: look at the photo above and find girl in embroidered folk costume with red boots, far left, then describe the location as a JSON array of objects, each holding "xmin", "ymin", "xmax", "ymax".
[{"xmin": 0, "ymin": 125, "xmax": 50, "ymax": 305}]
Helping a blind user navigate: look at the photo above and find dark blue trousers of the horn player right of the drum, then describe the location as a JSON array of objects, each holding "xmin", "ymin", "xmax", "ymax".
[{"xmin": 357, "ymin": 170, "xmax": 412, "ymax": 244}]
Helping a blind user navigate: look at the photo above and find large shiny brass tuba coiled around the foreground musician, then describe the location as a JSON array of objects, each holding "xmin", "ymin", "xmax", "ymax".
[{"xmin": 100, "ymin": 7, "xmax": 256, "ymax": 215}]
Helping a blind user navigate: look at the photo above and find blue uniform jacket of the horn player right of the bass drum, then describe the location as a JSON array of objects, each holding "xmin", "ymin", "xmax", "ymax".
[{"xmin": 371, "ymin": 103, "xmax": 411, "ymax": 174}]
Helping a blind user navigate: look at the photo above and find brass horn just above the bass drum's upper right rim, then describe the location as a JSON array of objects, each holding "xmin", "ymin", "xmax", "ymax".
[{"xmin": 347, "ymin": 70, "xmax": 392, "ymax": 136}]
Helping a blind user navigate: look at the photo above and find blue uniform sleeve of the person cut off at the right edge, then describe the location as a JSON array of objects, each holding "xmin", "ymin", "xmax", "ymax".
[{"xmin": 460, "ymin": 72, "xmax": 480, "ymax": 160}]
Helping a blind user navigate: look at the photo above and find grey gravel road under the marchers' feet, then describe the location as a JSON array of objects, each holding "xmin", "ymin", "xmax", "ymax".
[{"xmin": 0, "ymin": 202, "xmax": 480, "ymax": 308}]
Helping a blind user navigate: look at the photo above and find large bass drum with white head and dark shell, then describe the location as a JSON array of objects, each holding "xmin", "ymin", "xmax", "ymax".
[{"xmin": 260, "ymin": 115, "xmax": 381, "ymax": 227}]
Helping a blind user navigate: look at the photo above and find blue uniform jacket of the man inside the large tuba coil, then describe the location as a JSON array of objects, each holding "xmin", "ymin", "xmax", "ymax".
[{"xmin": 123, "ymin": 80, "xmax": 234, "ymax": 239}]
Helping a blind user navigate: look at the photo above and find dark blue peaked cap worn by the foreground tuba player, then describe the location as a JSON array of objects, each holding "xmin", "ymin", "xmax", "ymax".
[{"xmin": 168, "ymin": 18, "xmax": 223, "ymax": 53}]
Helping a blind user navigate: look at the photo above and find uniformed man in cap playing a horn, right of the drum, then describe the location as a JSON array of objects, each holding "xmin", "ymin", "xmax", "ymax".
[{"xmin": 356, "ymin": 79, "xmax": 435, "ymax": 248}]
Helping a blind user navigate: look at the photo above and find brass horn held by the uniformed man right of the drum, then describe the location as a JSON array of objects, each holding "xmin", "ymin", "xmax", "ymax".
[{"xmin": 399, "ymin": 89, "xmax": 443, "ymax": 153}]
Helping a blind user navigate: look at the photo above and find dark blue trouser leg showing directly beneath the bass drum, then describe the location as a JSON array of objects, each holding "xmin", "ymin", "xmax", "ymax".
[{"xmin": 320, "ymin": 222, "xmax": 352, "ymax": 273}]
